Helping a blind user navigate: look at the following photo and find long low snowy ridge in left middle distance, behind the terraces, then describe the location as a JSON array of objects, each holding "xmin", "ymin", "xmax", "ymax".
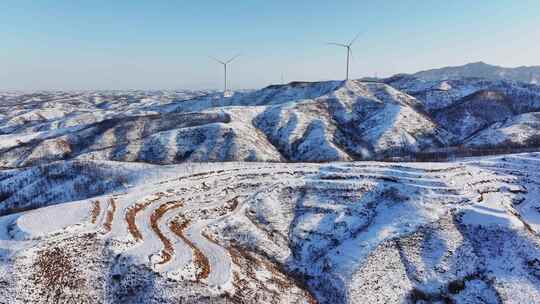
[{"xmin": 0, "ymin": 110, "xmax": 280, "ymax": 168}]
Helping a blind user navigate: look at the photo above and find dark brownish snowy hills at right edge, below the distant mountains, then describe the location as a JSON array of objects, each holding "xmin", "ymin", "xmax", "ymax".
[{"xmin": 384, "ymin": 75, "xmax": 540, "ymax": 149}]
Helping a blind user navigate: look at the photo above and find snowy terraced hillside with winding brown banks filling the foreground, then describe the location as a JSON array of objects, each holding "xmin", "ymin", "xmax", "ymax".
[{"xmin": 0, "ymin": 153, "xmax": 540, "ymax": 303}]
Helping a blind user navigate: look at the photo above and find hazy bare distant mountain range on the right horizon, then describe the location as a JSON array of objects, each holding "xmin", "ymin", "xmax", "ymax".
[{"xmin": 413, "ymin": 62, "xmax": 540, "ymax": 84}]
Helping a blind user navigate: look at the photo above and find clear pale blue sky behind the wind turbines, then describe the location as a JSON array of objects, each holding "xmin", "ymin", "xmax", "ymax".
[{"xmin": 0, "ymin": 0, "xmax": 540, "ymax": 90}]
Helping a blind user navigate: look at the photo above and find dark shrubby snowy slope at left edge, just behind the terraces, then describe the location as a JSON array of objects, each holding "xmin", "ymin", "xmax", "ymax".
[{"xmin": 0, "ymin": 161, "xmax": 179, "ymax": 215}]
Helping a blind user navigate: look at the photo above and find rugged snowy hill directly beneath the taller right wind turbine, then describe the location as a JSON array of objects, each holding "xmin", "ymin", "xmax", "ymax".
[{"xmin": 254, "ymin": 81, "xmax": 453, "ymax": 161}]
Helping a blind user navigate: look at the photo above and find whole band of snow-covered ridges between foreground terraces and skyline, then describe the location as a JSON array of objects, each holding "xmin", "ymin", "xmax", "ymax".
[{"xmin": 4, "ymin": 76, "xmax": 540, "ymax": 168}]
